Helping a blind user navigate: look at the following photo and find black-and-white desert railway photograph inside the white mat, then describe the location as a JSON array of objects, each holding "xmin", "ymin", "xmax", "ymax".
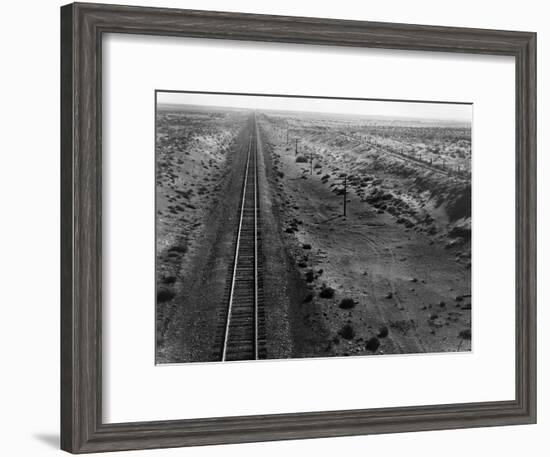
[{"xmin": 155, "ymin": 91, "xmax": 473, "ymax": 364}]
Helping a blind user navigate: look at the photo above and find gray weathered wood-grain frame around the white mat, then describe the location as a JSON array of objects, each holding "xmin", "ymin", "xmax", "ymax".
[{"xmin": 61, "ymin": 3, "xmax": 536, "ymax": 453}]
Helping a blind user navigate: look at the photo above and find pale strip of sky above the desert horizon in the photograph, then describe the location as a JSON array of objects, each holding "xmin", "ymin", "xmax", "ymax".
[{"xmin": 157, "ymin": 92, "xmax": 472, "ymax": 124}]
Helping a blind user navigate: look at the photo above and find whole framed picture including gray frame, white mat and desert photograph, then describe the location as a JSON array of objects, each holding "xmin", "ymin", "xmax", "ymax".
[{"xmin": 61, "ymin": 4, "xmax": 536, "ymax": 453}]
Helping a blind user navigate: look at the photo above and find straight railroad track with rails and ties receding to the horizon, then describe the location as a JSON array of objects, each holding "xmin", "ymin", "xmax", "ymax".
[{"xmin": 216, "ymin": 118, "xmax": 265, "ymax": 361}]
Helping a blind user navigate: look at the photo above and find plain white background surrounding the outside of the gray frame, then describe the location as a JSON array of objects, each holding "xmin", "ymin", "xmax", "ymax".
[{"xmin": 0, "ymin": 0, "xmax": 550, "ymax": 457}]
